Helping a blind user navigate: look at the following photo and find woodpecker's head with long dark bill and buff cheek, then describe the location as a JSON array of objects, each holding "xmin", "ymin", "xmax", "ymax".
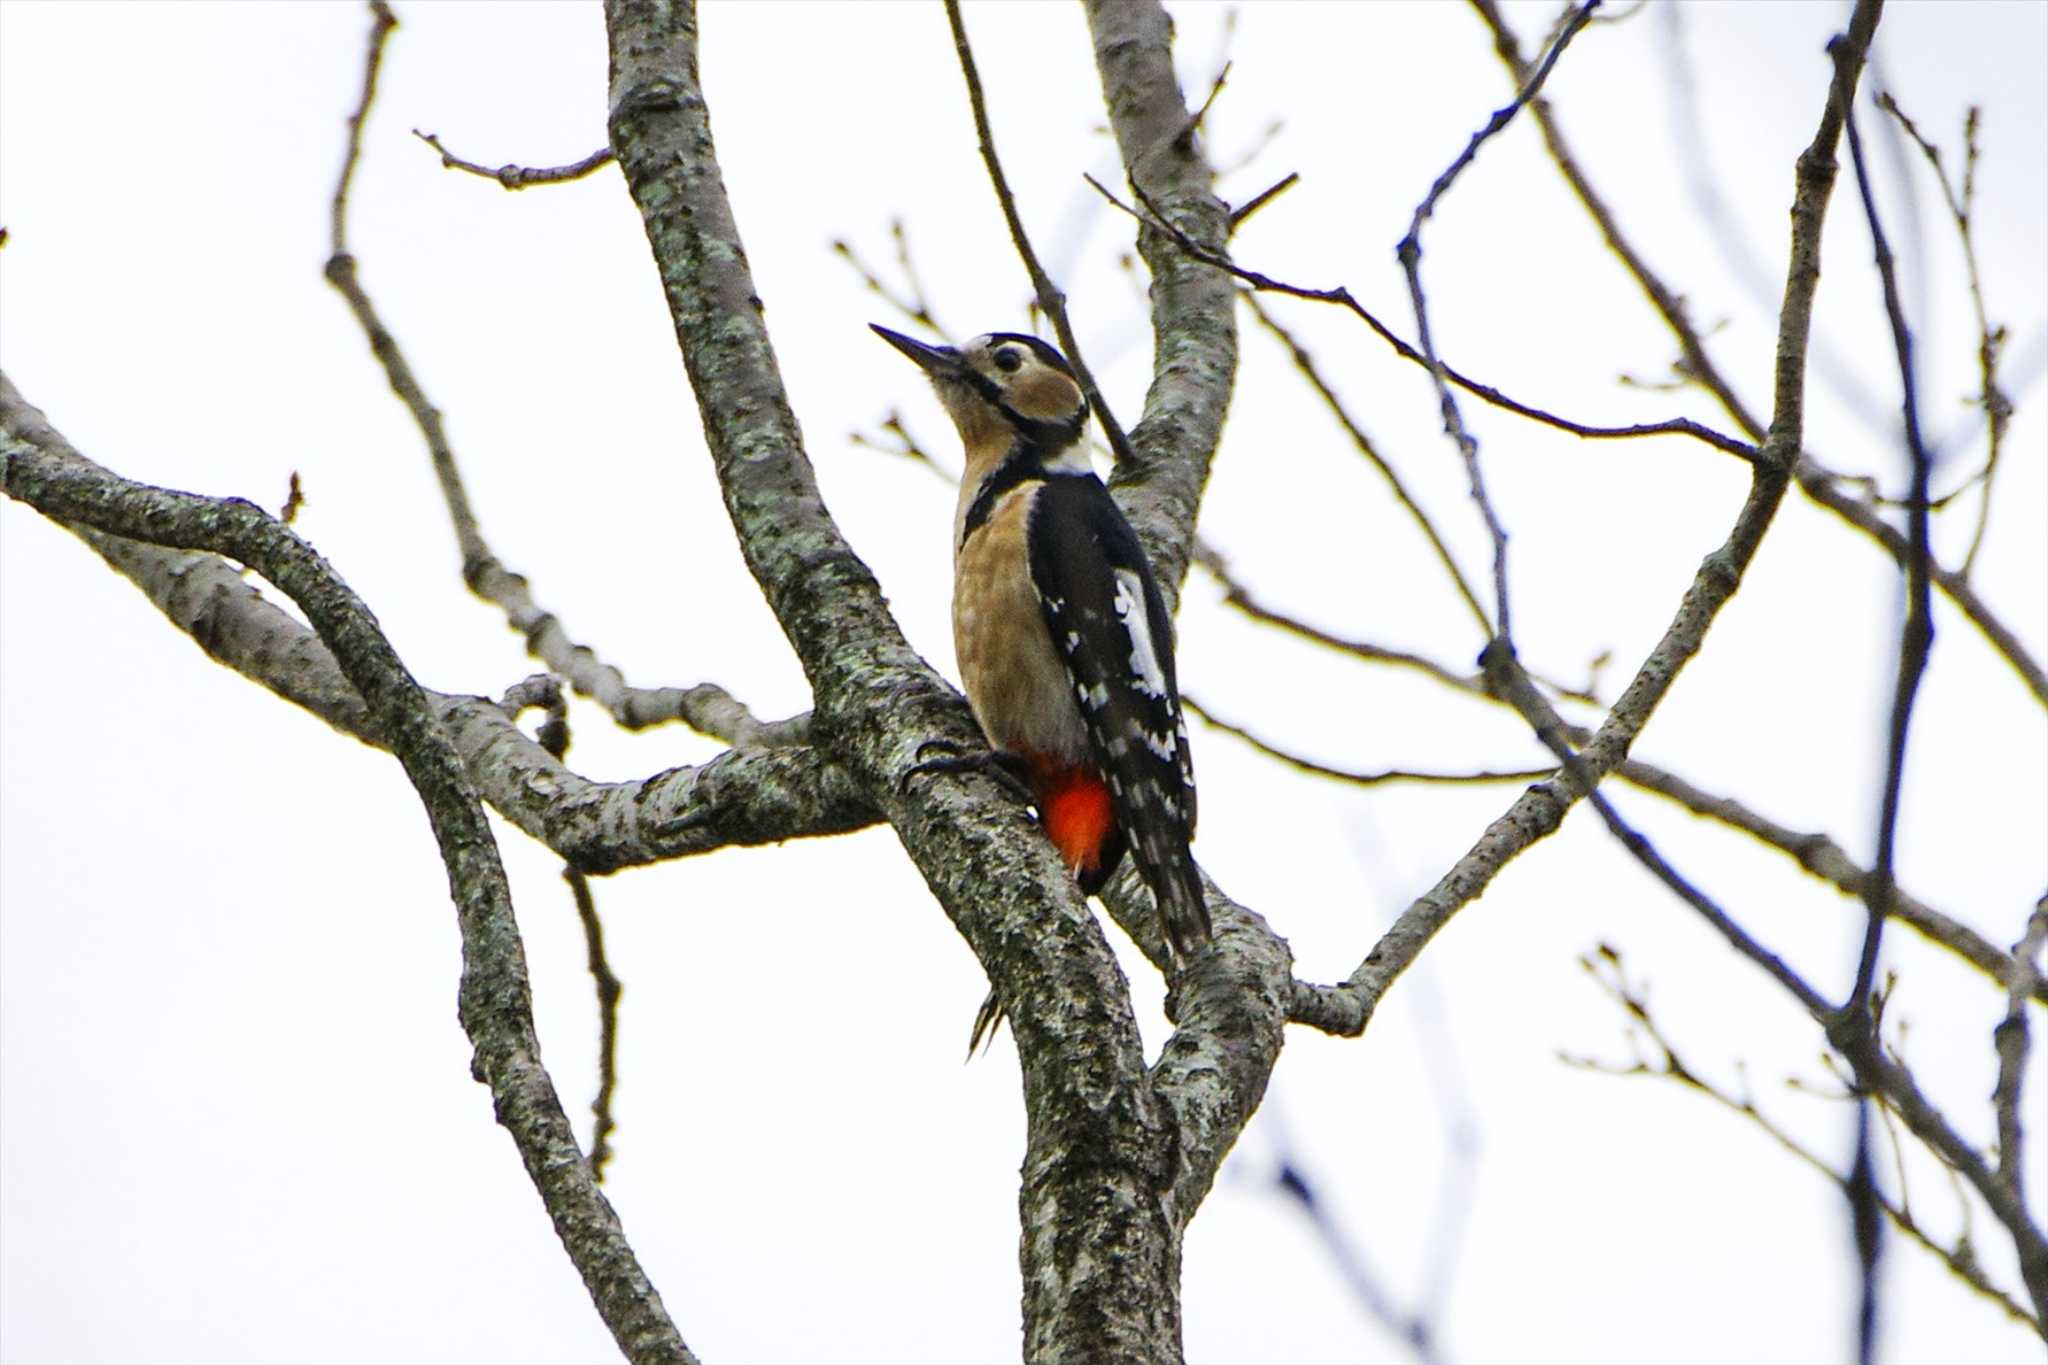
[{"xmin": 870, "ymin": 323, "xmax": 1087, "ymax": 463}]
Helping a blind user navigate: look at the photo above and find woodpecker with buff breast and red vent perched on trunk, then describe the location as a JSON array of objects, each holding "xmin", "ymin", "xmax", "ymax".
[{"xmin": 874, "ymin": 327, "xmax": 1210, "ymax": 994}]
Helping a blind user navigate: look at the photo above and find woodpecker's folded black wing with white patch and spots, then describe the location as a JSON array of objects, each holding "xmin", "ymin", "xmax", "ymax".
[{"xmin": 1028, "ymin": 475, "xmax": 1210, "ymax": 956}]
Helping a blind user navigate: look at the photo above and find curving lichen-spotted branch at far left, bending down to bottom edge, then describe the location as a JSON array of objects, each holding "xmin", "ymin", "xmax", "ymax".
[{"xmin": 0, "ymin": 376, "xmax": 696, "ymax": 1363}]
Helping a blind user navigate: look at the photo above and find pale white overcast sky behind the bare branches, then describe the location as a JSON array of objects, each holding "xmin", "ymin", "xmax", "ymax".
[{"xmin": 0, "ymin": 0, "xmax": 2048, "ymax": 1363}]
